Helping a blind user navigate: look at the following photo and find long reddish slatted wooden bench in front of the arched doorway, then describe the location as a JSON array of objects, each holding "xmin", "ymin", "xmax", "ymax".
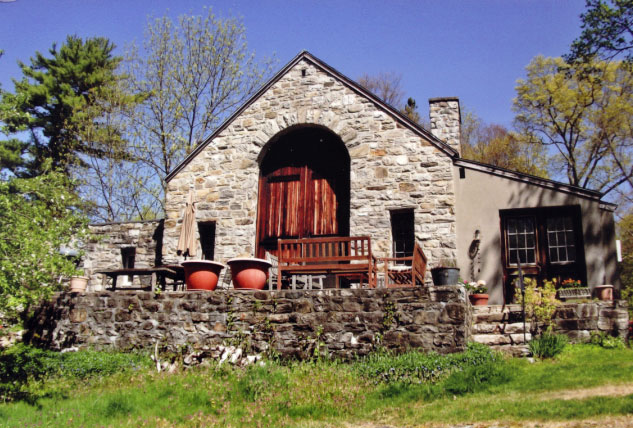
[{"xmin": 277, "ymin": 236, "xmax": 376, "ymax": 290}]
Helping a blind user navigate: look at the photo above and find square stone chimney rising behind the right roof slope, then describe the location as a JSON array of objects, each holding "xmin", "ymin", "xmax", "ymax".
[{"xmin": 429, "ymin": 97, "xmax": 462, "ymax": 156}]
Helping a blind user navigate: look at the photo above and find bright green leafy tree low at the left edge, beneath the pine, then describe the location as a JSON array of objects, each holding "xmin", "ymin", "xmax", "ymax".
[{"xmin": 0, "ymin": 169, "xmax": 87, "ymax": 322}]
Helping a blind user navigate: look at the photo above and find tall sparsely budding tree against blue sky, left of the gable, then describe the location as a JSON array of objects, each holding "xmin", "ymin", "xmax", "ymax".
[{"xmin": 127, "ymin": 9, "xmax": 272, "ymax": 212}]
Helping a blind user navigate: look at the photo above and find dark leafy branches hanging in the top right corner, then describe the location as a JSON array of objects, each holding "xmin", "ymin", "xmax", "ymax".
[{"xmin": 565, "ymin": 0, "xmax": 633, "ymax": 64}]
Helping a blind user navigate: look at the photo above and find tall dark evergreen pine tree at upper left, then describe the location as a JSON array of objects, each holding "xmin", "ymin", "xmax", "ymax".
[{"xmin": 0, "ymin": 36, "xmax": 120, "ymax": 175}]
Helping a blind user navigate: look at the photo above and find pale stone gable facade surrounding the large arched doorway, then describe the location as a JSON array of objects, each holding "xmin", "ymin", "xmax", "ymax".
[{"xmin": 163, "ymin": 58, "xmax": 456, "ymax": 270}]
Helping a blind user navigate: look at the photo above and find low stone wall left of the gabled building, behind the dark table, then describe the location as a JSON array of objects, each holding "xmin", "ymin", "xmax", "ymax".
[{"xmin": 83, "ymin": 220, "xmax": 163, "ymax": 291}]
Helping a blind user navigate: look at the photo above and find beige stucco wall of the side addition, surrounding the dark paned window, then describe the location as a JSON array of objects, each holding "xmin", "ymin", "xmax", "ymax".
[{"xmin": 454, "ymin": 166, "xmax": 619, "ymax": 304}]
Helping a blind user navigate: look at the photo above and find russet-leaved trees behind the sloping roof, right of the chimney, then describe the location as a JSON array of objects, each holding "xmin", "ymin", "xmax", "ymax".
[{"xmin": 461, "ymin": 110, "xmax": 547, "ymax": 177}]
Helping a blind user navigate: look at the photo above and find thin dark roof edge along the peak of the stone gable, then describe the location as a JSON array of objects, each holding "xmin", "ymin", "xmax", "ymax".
[{"xmin": 165, "ymin": 51, "xmax": 459, "ymax": 182}]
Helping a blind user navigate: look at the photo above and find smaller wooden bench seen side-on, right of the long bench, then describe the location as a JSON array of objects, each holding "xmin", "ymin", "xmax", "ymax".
[{"xmin": 377, "ymin": 242, "xmax": 426, "ymax": 288}]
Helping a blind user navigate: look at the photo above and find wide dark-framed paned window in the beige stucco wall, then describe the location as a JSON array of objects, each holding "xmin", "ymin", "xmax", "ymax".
[{"xmin": 500, "ymin": 206, "xmax": 587, "ymax": 302}]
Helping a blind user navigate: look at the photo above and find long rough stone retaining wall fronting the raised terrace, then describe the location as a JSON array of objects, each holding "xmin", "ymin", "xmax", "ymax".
[{"xmin": 25, "ymin": 287, "xmax": 471, "ymax": 358}]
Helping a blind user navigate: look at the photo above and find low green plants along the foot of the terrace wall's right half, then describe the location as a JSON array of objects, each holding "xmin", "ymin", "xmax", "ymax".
[{"xmin": 356, "ymin": 343, "xmax": 501, "ymax": 384}]
